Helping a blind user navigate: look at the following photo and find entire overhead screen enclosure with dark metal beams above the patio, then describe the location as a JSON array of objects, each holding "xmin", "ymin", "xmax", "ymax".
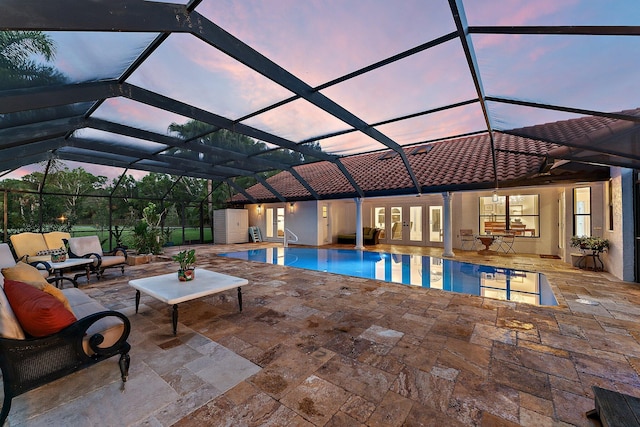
[{"xmin": 0, "ymin": 0, "xmax": 640, "ymax": 194}]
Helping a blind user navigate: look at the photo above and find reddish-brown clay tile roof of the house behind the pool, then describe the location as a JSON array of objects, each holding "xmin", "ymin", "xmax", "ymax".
[{"xmin": 232, "ymin": 109, "xmax": 640, "ymax": 202}]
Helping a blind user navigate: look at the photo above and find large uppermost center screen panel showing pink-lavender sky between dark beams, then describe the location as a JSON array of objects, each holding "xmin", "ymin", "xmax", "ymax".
[{"xmin": 202, "ymin": 0, "xmax": 455, "ymax": 87}]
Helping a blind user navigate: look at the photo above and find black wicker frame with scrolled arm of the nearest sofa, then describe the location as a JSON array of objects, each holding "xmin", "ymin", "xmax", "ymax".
[{"xmin": 0, "ymin": 311, "xmax": 131, "ymax": 426}]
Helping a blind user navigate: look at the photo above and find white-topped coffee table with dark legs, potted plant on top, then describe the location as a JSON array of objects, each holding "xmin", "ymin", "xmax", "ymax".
[{"xmin": 129, "ymin": 268, "xmax": 249, "ymax": 335}]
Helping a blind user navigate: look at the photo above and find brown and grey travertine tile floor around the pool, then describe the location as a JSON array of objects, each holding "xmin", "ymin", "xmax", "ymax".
[{"xmin": 9, "ymin": 244, "xmax": 640, "ymax": 426}]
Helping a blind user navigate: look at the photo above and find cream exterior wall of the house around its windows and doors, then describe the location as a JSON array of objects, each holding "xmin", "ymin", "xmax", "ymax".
[{"xmin": 248, "ymin": 172, "xmax": 635, "ymax": 281}]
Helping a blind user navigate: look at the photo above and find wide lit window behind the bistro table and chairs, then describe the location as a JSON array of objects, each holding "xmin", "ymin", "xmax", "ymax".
[{"xmin": 480, "ymin": 195, "xmax": 540, "ymax": 237}]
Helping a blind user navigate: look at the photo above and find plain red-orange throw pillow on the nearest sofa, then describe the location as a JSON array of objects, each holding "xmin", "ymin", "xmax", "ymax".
[{"xmin": 4, "ymin": 278, "xmax": 77, "ymax": 337}]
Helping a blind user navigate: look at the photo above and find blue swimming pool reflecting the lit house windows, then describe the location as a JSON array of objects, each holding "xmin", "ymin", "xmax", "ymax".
[{"xmin": 220, "ymin": 247, "xmax": 558, "ymax": 305}]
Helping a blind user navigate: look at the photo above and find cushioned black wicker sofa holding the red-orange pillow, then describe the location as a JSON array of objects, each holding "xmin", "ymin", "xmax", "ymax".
[{"xmin": 0, "ymin": 263, "xmax": 131, "ymax": 426}]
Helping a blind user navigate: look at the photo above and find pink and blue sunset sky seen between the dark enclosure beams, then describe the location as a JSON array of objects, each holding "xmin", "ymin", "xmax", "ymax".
[{"xmin": 2, "ymin": 0, "xmax": 640, "ymax": 181}]
